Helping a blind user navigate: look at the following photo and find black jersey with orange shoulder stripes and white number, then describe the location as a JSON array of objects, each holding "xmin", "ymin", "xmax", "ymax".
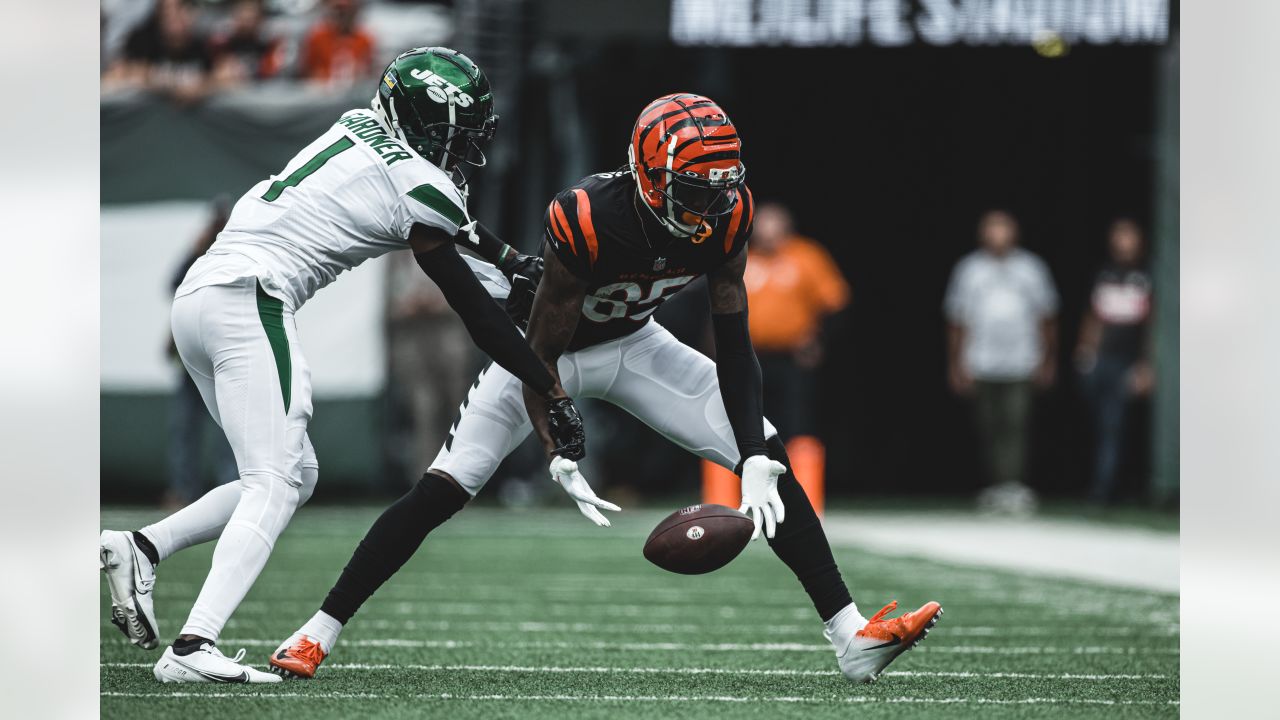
[{"xmin": 544, "ymin": 170, "xmax": 755, "ymax": 351}]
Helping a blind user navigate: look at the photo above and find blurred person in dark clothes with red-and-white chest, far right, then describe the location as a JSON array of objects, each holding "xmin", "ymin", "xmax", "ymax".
[{"xmin": 1075, "ymin": 218, "xmax": 1155, "ymax": 503}]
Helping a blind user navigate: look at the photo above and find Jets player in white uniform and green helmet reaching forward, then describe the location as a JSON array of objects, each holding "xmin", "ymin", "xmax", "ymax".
[{"xmin": 100, "ymin": 47, "xmax": 599, "ymax": 683}]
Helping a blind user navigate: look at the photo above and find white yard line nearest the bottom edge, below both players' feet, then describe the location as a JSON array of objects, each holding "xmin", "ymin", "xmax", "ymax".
[{"xmin": 99, "ymin": 691, "xmax": 1179, "ymax": 706}]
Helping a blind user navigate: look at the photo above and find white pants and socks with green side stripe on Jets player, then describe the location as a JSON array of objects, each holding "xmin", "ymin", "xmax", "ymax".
[{"xmin": 142, "ymin": 277, "xmax": 319, "ymax": 641}]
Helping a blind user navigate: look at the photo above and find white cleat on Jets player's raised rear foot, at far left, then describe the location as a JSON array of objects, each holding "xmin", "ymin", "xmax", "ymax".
[{"xmin": 99, "ymin": 530, "xmax": 160, "ymax": 650}]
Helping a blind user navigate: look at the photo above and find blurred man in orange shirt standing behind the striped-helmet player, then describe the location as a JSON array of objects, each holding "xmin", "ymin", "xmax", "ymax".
[{"xmin": 704, "ymin": 202, "xmax": 849, "ymax": 511}]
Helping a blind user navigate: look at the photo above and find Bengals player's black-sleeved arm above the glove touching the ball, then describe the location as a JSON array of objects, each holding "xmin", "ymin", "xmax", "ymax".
[{"xmin": 707, "ymin": 250, "xmax": 768, "ymax": 460}]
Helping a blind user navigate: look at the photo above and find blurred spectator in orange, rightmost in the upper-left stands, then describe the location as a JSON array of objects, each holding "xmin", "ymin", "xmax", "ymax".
[{"xmin": 300, "ymin": 0, "xmax": 380, "ymax": 86}]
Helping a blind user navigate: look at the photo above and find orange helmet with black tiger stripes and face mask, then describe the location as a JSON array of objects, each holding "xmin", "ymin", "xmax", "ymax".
[{"xmin": 627, "ymin": 94, "xmax": 746, "ymax": 237}]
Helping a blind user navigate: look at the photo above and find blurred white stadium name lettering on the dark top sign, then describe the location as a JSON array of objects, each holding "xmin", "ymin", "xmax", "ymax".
[{"xmin": 671, "ymin": 0, "xmax": 1169, "ymax": 47}]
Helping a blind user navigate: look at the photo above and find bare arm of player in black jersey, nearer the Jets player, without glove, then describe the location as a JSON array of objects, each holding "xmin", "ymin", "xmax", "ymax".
[{"xmin": 525, "ymin": 245, "xmax": 586, "ymax": 452}]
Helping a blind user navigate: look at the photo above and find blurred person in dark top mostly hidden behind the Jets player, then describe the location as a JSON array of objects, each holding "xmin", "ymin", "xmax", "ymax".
[{"xmin": 164, "ymin": 196, "xmax": 239, "ymax": 509}]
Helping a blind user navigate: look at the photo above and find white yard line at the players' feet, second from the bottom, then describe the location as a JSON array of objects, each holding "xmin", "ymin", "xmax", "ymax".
[{"xmin": 102, "ymin": 662, "xmax": 1169, "ymax": 680}]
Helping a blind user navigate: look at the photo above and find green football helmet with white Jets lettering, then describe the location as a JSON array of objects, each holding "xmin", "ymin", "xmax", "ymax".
[{"xmin": 372, "ymin": 47, "xmax": 498, "ymax": 173}]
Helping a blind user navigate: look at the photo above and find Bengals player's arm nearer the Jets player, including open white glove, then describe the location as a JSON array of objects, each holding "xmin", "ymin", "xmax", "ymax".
[{"xmin": 525, "ymin": 244, "xmax": 621, "ymax": 527}]
